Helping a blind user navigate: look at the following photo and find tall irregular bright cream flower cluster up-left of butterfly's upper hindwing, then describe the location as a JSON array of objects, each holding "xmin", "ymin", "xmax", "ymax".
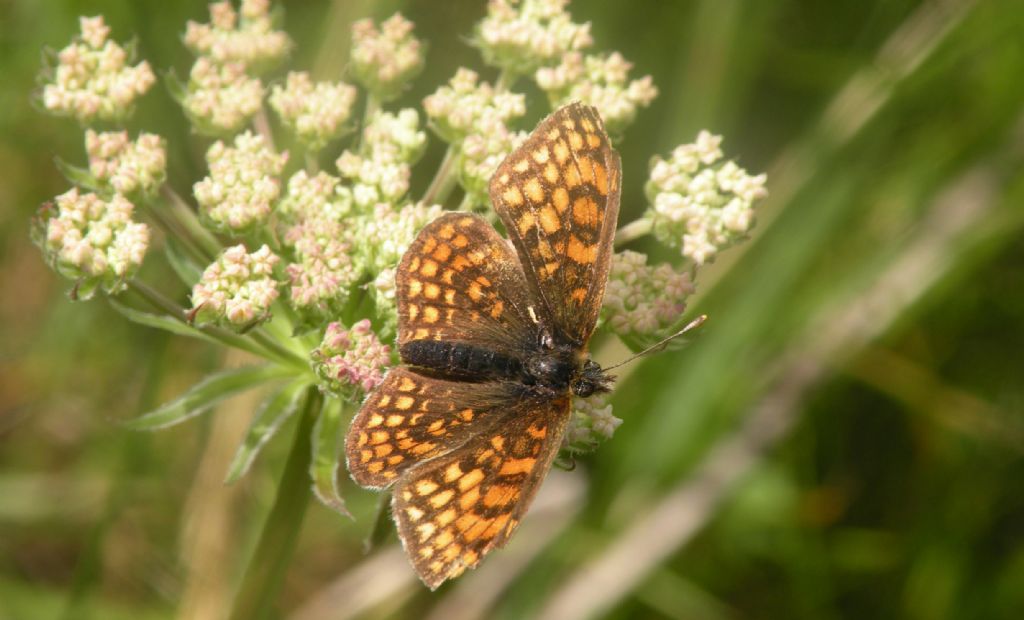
[{"xmin": 336, "ymin": 108, "xmax": 427, "ymax": 212}]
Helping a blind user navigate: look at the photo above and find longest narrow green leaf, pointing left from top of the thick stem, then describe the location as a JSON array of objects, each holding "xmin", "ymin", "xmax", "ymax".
[{"xmin": 125, "ymin": 365, "xmax": 295, "ymax": 430}]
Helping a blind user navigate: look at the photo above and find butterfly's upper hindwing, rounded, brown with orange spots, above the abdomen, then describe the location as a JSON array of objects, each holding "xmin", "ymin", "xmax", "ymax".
[{"xmin": 395, "ymin": 213, "xmax": 536, "ymax": 352}]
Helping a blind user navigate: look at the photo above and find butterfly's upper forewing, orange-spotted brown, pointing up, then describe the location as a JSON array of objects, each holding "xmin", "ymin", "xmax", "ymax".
[{"xmin": 490, "ymin": 98, "xmax": 622, "ymax": 348}]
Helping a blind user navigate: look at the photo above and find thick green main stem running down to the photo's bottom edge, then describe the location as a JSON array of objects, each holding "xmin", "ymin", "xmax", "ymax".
[{"xmin": 230, "ymin": 385, "xmax": 324, "ymax": 620}]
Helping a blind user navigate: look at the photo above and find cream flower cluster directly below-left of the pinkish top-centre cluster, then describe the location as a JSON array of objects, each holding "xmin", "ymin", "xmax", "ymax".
[{"xmin": 270, "ymin": 72, "xmax": 355, "ymax": 151}]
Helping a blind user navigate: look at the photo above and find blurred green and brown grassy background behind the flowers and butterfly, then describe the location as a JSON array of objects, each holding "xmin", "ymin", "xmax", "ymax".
[{"xmin": 0, "ymin": 0, "xmax": 1024, "ymax": 620}]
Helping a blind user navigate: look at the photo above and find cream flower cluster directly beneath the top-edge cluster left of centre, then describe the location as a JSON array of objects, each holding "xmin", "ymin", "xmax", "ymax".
[{"xmin": 180, "ymin": 56, "xmax": 263, "ymax": 135}]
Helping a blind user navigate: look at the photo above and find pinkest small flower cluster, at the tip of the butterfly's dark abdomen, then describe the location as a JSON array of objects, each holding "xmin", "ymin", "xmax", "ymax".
[{"xmin": 311, "ymin": 319, "xmax": 391, "ymax": 401}]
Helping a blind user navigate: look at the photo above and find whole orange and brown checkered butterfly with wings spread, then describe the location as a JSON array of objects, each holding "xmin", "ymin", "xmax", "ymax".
[{"xmin": 345, "ymin": 102, "xmax": 622, "ymax": 588}]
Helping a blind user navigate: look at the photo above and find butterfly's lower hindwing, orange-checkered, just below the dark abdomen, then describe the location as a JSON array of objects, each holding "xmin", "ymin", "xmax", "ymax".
[{"xmin": 345, "ymin": 367, "xmax": 522, "ymax": 489}]
